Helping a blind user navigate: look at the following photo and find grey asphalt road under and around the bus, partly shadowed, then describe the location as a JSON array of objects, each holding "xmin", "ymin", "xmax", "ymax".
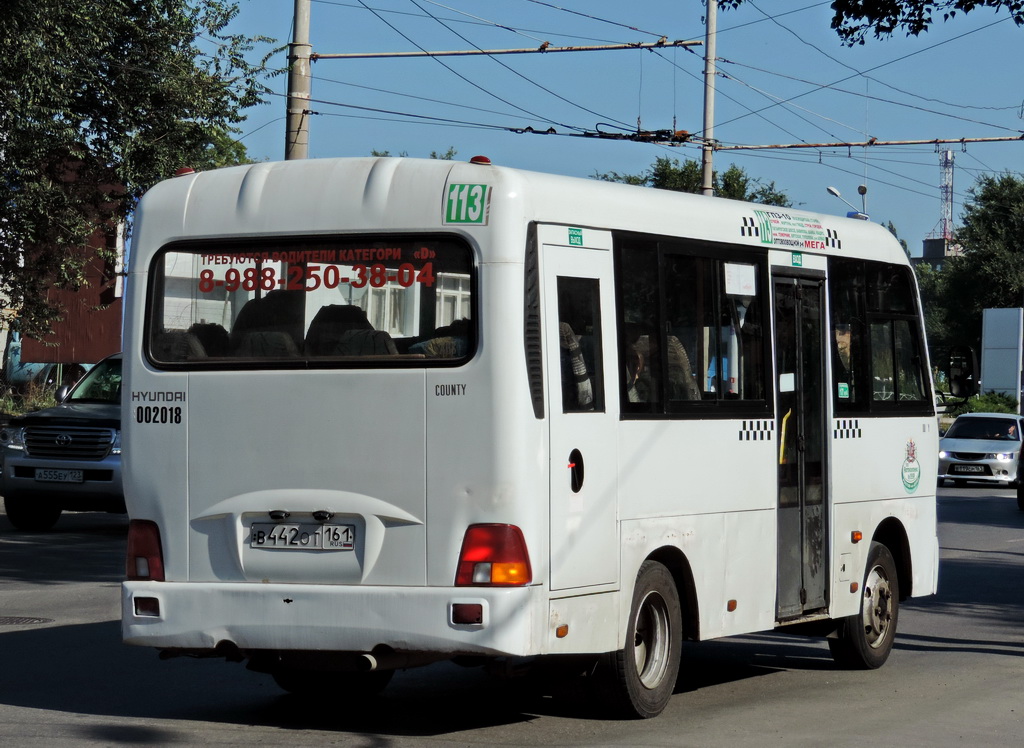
[{"xmin": 0, "ymin": 488, "xmax": 1024, "ymax": 748}]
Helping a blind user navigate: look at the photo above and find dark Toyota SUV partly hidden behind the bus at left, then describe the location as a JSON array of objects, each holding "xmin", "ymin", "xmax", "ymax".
[{"xmin": 0, "ymin": 354, "xmax": 125, "ymax": 531}]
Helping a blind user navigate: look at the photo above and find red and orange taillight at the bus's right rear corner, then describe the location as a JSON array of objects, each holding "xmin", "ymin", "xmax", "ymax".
[{"xmin": 455, "ymin": 525, "xmax": 534, "ymax": 586}]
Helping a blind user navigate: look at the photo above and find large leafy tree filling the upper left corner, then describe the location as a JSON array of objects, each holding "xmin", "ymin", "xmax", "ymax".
[{"xmin": 0, "ymin": 0, "xmax": 270, "ymax": 335}]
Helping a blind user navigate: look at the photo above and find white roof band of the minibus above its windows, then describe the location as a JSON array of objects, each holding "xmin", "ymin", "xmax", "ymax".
[{"xmin": 132, "ymin": 157, "xmax": 907, "ymax": 263}]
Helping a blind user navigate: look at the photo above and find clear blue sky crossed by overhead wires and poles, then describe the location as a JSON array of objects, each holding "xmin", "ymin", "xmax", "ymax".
[{"xmin": 231, "ymin": 0, "xmax": 1024, "ymax": 255}]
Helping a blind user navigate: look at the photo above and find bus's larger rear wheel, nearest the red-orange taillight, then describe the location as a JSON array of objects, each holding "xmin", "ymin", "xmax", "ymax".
[{"xmin": 598, "ymin": 560, "xmax": 683, "ymax": 719}]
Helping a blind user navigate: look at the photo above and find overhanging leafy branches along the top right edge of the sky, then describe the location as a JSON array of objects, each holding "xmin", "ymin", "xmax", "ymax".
[{"xmin": 721, "ymin": 0, "xmax": 1024, "ymax": 45}]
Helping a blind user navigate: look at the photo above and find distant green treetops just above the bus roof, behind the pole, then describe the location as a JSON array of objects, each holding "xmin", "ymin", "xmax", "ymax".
[{"xmin": 594, "ymin": 156, "xmax": 793, "ymax": 208}]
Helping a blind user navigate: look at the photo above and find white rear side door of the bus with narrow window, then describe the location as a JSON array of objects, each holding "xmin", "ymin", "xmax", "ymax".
[{"xmin": 541, "ymin": 240, "xmax": 618, "ymax": 589}]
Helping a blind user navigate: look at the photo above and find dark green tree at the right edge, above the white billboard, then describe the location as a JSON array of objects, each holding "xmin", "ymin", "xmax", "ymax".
[{"xmin": 935, "ymin": 173, "xmax": 1024, "ymax": 346}]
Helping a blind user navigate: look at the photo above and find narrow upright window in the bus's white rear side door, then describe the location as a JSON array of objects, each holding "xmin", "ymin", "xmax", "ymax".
[{"xmin": 558, "ymin": 277, "xmax": 604, "ymax": 413}]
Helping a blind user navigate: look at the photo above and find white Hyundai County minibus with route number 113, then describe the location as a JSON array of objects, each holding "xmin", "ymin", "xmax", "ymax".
[{"xmin": 122, "ymin": 157, "xmax": 938, "ymax": 717}]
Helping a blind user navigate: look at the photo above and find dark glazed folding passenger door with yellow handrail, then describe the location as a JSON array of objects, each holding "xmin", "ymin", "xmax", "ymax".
[{"xmin": 774, "ymin": 277, "xmax": 828, "ymax": 621}]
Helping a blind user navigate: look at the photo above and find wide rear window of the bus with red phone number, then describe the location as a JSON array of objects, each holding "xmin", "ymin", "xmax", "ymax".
[{"xmin": 147, "ymin": 236, "xmax": 475, "ymax": 368}]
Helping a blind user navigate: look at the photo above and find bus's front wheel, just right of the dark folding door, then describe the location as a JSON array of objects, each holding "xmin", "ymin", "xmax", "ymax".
[{"xmin": 828, "ymin": 541, "xmax": 899, "ymax": 670}]
